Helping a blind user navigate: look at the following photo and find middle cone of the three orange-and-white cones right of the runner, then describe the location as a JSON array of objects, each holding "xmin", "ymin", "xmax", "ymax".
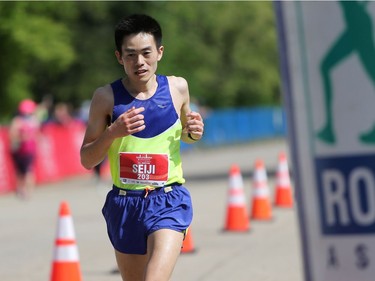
[{"xmin": 251, "ymin": 159, "xmax": 272, "ymax": 220}]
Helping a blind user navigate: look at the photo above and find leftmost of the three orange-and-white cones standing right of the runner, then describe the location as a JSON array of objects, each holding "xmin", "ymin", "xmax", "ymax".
[{"xmin": 224, "ymin": 165, "xmax": 250, "ymax": 231}]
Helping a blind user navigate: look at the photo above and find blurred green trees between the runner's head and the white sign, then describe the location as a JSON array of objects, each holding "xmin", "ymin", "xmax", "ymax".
[{"xmin": 155, "ymin": 1, "xmax": 280, "ymax": 108}]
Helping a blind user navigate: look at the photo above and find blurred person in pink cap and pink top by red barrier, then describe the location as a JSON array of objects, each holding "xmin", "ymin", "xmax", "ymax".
[{"xmin": 9, "ymin": 99, "xmax": 40, "ymax": 199}]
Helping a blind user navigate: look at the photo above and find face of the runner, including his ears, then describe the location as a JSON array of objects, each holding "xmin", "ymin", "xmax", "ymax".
[{"xmin": 116, "ymin": 33, "xmax": 163, "ymax": 81}]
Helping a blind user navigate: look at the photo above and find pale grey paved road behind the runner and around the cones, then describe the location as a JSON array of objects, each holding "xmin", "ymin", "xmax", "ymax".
[{"xmin": 0, "ymin": 140, "xmax": 303, "ymax": 281}]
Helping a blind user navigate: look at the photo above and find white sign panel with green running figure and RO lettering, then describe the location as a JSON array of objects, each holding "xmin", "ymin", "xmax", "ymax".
[{"xmin": 275, "ymin": 1, "xmax": 375, "ymax": 281}]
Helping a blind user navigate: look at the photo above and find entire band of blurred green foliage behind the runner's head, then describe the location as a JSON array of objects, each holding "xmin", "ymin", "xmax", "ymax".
[{"xmin": 0, "ymin": 1, "xmax": 280, "ymax": 120}]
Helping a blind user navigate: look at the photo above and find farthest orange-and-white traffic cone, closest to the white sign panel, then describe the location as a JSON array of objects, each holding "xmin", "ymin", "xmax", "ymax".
[{"xmin": 275, "ymin": 152, "xmax": 293, "ymax": 208}]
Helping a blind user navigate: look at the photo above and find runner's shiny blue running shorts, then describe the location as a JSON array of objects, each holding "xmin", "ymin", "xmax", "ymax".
[{"xmin": 102, "ymin": 184, "xmax": 193, "ymax": 255}]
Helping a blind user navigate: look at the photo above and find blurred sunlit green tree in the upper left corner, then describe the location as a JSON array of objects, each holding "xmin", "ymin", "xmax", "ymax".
[{"xmin": 0, "ymin": 2, "xmax": 75, "ymax": 119}]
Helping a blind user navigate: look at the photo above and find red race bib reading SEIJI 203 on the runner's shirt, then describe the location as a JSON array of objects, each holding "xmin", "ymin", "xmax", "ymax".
[{"xmin": 119, "ymin": 152, "xmax": 169, "ymax": 187}]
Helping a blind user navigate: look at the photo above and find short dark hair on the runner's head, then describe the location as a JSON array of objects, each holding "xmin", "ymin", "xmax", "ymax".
[{"xmin": 115, "ymin": 14, "xmax": 162, "ymax": 53}]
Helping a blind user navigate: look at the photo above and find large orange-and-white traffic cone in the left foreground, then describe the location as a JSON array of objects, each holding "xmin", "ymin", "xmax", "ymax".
[{"xmin": 51, "ymin": 202, "xmax": 82, "ymax": 281}]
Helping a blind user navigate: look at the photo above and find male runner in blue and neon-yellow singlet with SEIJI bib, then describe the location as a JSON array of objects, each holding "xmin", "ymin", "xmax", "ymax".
[{"xmin": 81, "ymin": 15, "xmax": 204, "ymax": 281}]
